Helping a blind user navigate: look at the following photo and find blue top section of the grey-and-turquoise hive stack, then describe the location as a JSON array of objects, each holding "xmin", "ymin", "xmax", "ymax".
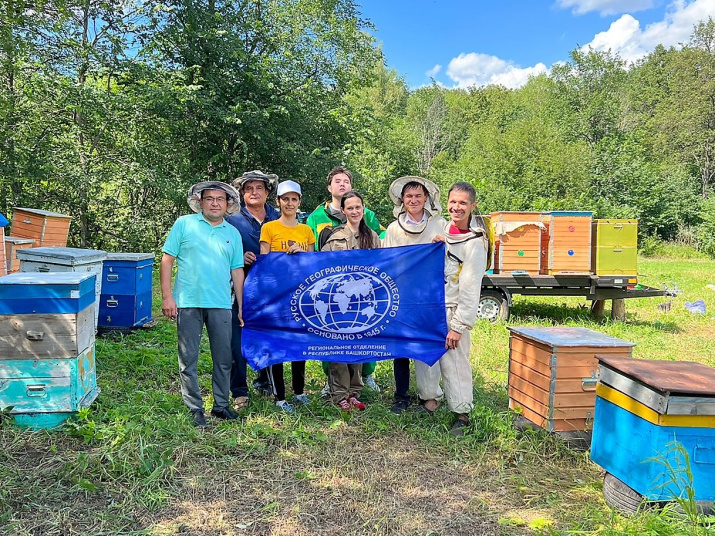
[{"xmin": 0, "ymin": 272, "xmax": 96, "ymax": 315}]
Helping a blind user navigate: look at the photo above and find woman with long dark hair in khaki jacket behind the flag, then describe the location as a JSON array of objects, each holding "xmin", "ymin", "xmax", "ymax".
[{"xmin": 321, "ymin": 190, "xmax": 380, "ymax": 411}]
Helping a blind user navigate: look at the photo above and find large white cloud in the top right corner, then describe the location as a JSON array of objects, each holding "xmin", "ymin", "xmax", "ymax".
[{"xmin": 583, "ymin": 0, "xmax": 715, "ymax": 61}]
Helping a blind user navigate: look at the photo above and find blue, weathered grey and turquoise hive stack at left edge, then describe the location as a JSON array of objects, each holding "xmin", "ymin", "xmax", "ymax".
[{"xmin": 0, "ymin": 272, "xmax": 99, "ymax": 428}]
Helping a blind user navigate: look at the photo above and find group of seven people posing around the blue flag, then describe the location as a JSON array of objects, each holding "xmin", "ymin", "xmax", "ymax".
[{"xmin": 160, "ymin": 166, "xmax": 488, "ymax": 435}]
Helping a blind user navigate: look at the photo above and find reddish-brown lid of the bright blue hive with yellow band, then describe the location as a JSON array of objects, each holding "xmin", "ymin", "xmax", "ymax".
[{"xmin": 596, "ymin": 355, "xmax": 715, "ymax": 397}]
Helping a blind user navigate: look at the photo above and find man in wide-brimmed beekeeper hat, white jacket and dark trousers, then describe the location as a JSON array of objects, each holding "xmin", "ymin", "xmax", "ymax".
[{"xmin": 382, "ymin": 176, "xmax": 445, "ymax": 415}]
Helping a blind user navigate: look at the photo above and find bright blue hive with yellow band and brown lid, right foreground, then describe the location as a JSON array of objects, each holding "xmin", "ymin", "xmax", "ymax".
[{"xmin": 591, "ymin": 356, "xmax": 715, "ymax": 510}]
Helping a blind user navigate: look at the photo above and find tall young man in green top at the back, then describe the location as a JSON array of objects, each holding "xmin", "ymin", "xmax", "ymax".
[{"xmin": 305, "ymin": 166, "xmax": 384, "ymax": 392}]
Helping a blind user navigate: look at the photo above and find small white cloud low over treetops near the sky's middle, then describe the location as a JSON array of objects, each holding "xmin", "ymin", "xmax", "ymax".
[{"xmin": 446, "ymin": 52, "xmax": 549, "ymax": 89}]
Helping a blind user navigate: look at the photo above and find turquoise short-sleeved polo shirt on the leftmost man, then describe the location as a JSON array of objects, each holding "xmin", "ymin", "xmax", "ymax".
[{"xmin": 162, "ymin": 213, "xmax": 243, "ymax": 309}]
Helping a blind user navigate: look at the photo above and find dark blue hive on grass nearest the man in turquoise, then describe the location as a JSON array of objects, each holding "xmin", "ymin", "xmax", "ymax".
[{"xmin": 98, "ymin": 253, "xmax": 154, "ymax": 331}]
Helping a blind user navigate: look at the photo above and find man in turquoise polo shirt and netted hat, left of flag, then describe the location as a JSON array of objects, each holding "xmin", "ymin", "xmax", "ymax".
[{"xmin": 159, "ymin": 181, "xmax": 243, "ymax": 427}]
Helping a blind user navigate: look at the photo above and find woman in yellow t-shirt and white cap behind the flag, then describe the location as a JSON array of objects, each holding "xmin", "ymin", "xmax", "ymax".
[{"xmin": 260, "ymin": 181, "xmax": 315, "ymax": 412}]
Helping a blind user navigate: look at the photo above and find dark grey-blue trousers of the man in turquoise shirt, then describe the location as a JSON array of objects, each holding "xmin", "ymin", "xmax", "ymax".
[{"xmin": 176, "ymin": 307, "xmax": 231, "ymax": 411}]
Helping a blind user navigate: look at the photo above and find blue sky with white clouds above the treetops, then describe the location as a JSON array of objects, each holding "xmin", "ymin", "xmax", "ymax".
[{"xmin": 357, "ymin": 0, "xmax": 715, "ymax": 88}]
